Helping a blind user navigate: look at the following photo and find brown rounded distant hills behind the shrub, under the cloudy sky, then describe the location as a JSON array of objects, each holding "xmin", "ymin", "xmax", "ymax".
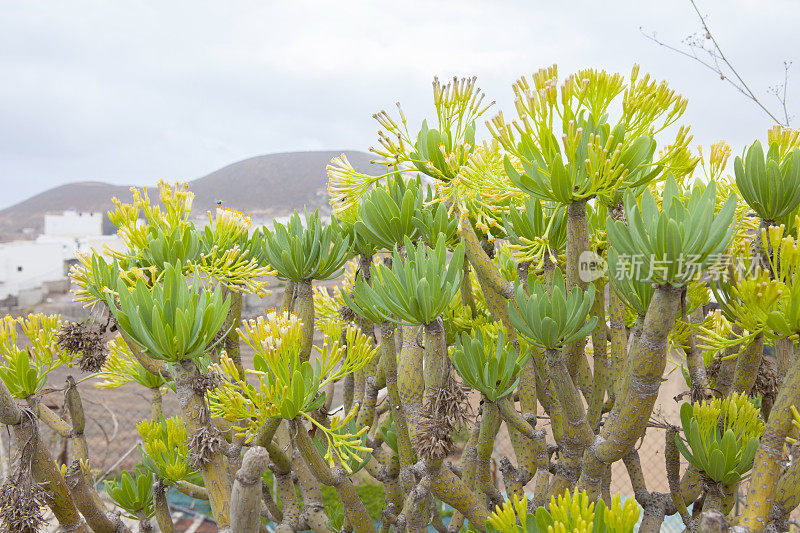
[{"xmin": 0, "ymin": 151, "xmax": 381, "ymax": 241}]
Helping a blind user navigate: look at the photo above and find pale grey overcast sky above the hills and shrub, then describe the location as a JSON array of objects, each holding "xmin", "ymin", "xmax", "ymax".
[{"xmin": 0, "ymin": 0, "xmax": 800, "ymax": 207}]
